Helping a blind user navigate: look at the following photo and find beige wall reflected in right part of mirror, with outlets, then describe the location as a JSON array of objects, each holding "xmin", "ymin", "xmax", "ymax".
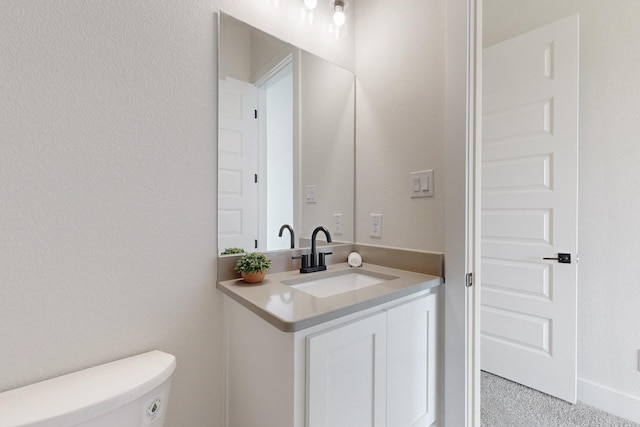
[{"xmin": 297, "ymin": 51, "xmax": 356, "ymax": 242}]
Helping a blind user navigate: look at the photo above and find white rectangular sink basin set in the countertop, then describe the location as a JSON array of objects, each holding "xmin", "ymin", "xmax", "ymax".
[{"xmin": 282, "ymin": 269, "xmax": 397, "ymax": 298}]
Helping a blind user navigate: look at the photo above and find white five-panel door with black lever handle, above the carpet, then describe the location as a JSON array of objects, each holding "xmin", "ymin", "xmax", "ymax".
[{"xmin": 481, "ymin": 15, "xmax": 578, "ymax": 402}]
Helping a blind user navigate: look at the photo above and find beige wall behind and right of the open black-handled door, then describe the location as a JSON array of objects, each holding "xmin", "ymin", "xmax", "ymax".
[{"xmin": 484, "ymin": 0, "xmax": 640, "ymax": 412}]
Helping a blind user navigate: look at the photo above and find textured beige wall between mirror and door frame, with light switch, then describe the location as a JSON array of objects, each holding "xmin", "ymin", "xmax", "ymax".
[{"xmin": 356, "ymin": 0, "xmax": 445, "ymax": 251}]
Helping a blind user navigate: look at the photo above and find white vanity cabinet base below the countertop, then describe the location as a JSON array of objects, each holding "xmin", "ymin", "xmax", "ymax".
[{"xmin": 225, "ymin": 292, "xmax": 436, "ymax": 427}]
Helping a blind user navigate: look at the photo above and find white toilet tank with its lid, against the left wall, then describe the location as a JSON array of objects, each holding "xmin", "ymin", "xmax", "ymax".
[{"xmin": 0, "ymin": 350, "xmax": 176, "ymax": 427}]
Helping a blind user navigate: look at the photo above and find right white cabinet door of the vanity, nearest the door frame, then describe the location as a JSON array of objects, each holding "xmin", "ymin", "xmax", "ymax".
[{"xmin": 387, "ymin": 295, "xmax": 436, "ymax": 427}]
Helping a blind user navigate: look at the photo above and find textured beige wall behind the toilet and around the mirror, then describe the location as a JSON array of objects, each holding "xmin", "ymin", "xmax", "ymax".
[{"xmin": 0, "ymin": 0, "xmax": 353, "ymax": 427}]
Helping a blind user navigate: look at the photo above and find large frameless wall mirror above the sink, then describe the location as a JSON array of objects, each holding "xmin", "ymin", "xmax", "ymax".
[{"xmin": 218, "ymin": 13, "xmax": 355, "ymax": 253}]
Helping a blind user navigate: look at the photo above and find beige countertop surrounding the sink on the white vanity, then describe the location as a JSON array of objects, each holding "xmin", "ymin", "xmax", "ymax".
[{"xmin": 216, "ymin": 263, "xmax": 442, "ymax": 332}]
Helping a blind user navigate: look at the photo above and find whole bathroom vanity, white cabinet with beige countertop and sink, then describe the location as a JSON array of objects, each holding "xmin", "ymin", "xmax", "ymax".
[{"xmin": 217, "ymin": 263, "xmax": 441, "ymax": 427}]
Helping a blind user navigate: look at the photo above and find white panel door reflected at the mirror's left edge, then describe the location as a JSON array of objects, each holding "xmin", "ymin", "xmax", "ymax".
[{"xmin": 218, "ymin": 78, "xmax": 258, "ymax": 252}]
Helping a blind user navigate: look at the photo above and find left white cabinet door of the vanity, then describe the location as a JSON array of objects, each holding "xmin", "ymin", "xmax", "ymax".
[{"xmin": 307, "ymin": 312, "xmax": 387, "ymax": 427}]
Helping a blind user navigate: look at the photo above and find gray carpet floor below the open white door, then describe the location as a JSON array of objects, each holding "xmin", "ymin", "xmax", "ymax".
[{"xmin": 480, "ymin": 372, "xmax": 640, "ymax": 427}]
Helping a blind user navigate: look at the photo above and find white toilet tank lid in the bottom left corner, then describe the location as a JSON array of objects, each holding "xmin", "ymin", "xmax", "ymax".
[{"xmin": 0, "ymin": 350, "xmax": 176, "ymax": 426}]
